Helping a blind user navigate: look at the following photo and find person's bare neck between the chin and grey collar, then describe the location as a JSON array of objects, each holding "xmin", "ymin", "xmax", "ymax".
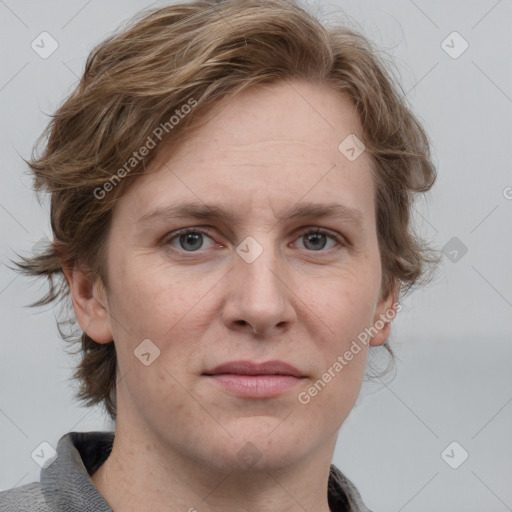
[{"xmin": 91, "ymin": 418, "xmax": 336, "ymax": 512}]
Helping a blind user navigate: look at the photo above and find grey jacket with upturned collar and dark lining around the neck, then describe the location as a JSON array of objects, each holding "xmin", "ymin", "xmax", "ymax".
[{"xmin": 0, "ymin": 432, "xmax": 371, "ymax": 512}]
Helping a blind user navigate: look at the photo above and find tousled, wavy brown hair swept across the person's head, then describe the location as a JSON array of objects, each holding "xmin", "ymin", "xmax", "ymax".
[{"xmin": 15, "ymin": 0, "xmax": 438, "ymax": 419}]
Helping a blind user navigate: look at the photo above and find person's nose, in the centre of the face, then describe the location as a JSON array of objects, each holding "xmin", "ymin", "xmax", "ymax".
[{"xmin": 223, "ymin": 239, "xmax": 296, "ymax": 338}]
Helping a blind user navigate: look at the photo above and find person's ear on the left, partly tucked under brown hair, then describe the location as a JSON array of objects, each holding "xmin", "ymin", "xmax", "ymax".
[{"xmin": 63, "ymin": 265, "xmax": 114, "ymax": 343}]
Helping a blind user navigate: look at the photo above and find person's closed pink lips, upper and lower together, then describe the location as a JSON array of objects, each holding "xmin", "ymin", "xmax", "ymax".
[{"xmin": 204, "ymin": 361, "xmax": 305, "ymax": 398}]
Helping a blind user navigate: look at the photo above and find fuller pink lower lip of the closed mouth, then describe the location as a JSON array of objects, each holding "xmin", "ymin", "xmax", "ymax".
[{"xmin": 206, "ymin": 373, "xmax": 302, "ymax": 398}]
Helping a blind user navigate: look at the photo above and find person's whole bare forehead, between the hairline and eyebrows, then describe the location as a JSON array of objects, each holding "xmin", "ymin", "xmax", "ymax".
[{"xmin": 116, "ymin": 81, "xmax": 374, "ymax": 226}]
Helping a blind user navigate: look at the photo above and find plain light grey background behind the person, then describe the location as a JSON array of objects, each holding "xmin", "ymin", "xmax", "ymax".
[{"xmin": 0, "ymin": 0, "xmax": 512, "ymax": 512}]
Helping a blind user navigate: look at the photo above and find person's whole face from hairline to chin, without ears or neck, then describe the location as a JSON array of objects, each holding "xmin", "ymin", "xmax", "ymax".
[{"xmin": 85, "ymin": 81, "xmax": 396, "ymax": 468}]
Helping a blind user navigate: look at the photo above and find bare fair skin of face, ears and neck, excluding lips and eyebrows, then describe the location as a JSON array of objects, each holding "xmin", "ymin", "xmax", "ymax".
[{"xmin": 66, "ymin": 80, "xmax": 397, "ymax": 512}]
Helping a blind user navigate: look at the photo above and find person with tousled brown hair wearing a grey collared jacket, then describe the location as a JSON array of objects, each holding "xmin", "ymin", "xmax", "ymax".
[{"xmin": 0, "ymin": 0, "xmax": 436, "ymax": 512}]
